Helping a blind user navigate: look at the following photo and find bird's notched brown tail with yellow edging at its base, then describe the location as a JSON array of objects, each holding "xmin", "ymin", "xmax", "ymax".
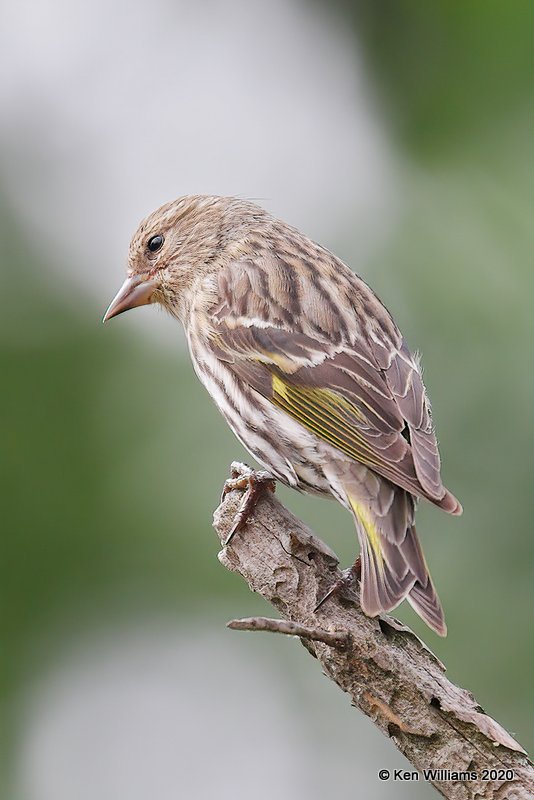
[{"xmin": 349, "ymin": 487, "xmax": 447, "ymax": 636}]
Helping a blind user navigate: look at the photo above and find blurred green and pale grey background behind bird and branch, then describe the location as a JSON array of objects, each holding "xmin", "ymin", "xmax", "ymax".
[{"xmin": 0, "ymin": 0, "xmax": 534, "ymax": 800}]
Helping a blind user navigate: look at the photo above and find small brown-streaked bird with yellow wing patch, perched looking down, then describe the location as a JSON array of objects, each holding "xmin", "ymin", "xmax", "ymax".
[{"xmin": 104, "ymin": 195, "xmax": 462, "ymax": 636}]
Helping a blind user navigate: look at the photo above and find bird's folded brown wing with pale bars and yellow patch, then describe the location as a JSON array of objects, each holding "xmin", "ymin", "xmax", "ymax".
[{"xmin": 205, "ymin": 251, "xmax": 457, "ymax": 512}]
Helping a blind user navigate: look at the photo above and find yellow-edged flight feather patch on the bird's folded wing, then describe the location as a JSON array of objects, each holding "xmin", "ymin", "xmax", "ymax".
[{"xmin": 272, "ymin": 374, "xmax": 380, "ymax": 467}]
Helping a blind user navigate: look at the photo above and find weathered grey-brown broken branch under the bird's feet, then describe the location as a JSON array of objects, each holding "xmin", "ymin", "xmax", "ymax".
[{"xmin": 214, "ymin": 464, "xmax": 534, "ymax": 800}]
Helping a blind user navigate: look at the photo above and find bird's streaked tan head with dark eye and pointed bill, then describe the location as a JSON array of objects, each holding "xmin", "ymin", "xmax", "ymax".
[{"xmin": 104, "ymin": 195, "xmax": 265, "ymax": 322}]
